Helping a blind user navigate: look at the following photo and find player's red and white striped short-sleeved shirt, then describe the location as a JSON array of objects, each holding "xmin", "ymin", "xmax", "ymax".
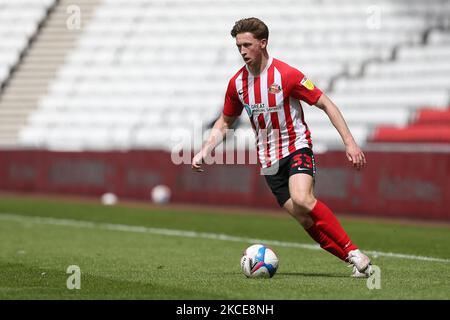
[{"xmin": 223, "ymin": 58, "xmax": 322, "ymax": 168}]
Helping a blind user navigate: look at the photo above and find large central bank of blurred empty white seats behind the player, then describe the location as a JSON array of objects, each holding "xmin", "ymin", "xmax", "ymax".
[{"xmin": 0, "ymin": 0, "xmax": 450, "ymax": 150}]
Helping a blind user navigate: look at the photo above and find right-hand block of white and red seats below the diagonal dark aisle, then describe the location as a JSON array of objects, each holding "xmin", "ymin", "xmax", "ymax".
[{"xmin": 331, "ymin": 29, "xmax": 450, "ymax": 148}]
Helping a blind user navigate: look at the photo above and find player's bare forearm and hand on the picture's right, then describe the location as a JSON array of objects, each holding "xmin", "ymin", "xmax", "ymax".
[{"xmin": 315, "ymin": 93, "xmax": 366, "ymax": 170}]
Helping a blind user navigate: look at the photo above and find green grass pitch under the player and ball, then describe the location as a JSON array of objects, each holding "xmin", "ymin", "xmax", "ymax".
[{"xmin": 0, "ymin": 196, "xmax": 450, "ymax": 300}]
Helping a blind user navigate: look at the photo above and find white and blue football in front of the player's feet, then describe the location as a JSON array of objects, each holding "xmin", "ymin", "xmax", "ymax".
[{"xmin": 241, "ymin": 244, "xmax": 278, "ymax": 278}]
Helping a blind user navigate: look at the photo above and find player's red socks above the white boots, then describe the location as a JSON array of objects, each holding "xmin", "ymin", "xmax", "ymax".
[{"xmin": 306, "ymin": 200, "xmax": 358, "ymax": 261}]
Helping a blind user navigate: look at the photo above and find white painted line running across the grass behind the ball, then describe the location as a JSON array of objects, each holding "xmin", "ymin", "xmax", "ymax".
[{"xmin": 0, "ymin": 213, "xmax": 450, "ymax": 263}]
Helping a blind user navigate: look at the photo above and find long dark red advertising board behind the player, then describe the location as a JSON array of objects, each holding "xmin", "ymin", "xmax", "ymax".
[{"xmin": 0, "ymin": 150, "xmax": 450, "ymax": 221}]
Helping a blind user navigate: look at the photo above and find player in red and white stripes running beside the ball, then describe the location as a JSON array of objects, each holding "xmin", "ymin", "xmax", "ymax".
[{"xmin": 192, "ymin": 18, "xmax": 372, "ymax": 277}]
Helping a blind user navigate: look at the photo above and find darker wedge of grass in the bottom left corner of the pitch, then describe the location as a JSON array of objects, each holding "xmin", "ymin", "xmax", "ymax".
[{"xmin": 0, "ymin": 262, "xmax": 224, "ymax": 300}]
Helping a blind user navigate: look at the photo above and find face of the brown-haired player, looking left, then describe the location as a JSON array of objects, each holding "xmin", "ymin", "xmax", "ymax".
[{"xmin": 236, "ymin": 32, "xmax": 267, "ymax": 66}]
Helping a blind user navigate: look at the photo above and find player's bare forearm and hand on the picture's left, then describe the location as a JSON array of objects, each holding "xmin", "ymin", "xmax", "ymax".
[{"xmin": 192, "ymin": 113, "xmax": 237, "ymax": 172}]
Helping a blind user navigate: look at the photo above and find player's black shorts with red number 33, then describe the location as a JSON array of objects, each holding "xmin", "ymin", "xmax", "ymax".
[{"xmin": 264, "ymin": 147, "xmax": 316, "ymax": 207}]
